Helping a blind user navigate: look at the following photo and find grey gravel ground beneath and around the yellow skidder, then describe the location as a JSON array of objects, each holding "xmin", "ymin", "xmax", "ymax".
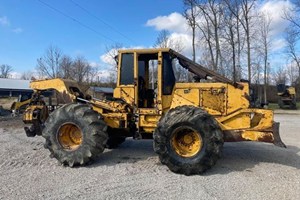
[{"xmin": 0, "ymin": 111, "xmax": 300, "ymax": 200}]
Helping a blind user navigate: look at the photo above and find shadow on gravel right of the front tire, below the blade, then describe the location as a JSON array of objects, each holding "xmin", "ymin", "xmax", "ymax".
[{"xmin": 204, "ymin": 142, "xmax": 300, "ymax": 175}]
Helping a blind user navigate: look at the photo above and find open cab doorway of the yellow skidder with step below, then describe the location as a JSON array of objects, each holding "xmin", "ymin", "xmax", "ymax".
[{"xmin": 135, "ymin": 51, "xmax": 161, "ymax": 133}]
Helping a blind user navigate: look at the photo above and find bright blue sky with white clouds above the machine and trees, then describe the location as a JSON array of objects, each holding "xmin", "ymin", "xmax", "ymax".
[{"xmin": 0, "ymin": 0, "xmax": 292, "ymax": 78}]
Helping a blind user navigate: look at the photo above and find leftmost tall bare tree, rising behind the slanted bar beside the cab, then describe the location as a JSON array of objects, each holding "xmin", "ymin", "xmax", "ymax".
[{"xmin": 183, "ymin": 0, "xmax": 200, "ymax": 62}]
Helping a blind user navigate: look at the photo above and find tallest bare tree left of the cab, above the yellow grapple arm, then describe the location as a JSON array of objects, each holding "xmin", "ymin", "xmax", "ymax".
[{"xmin": 36, "ymin": 46, "xmax": 63, "ymax": 78}]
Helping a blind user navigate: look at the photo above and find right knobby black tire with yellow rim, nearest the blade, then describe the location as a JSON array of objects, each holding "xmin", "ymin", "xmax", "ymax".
[{"xmin": 153, "ymin": 106, "xmax": 224, "ymax": 175}]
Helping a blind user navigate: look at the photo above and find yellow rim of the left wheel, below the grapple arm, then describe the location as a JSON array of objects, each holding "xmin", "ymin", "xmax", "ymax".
[{"xmin": 58, "ymin": 123, "xmax": 83, "ymax": 151}]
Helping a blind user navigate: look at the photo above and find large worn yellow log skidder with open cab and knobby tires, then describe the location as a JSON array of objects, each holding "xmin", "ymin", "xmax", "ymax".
[{"xmin": 23, "ymin": 49, "xmax": 285, "ymax": 175}]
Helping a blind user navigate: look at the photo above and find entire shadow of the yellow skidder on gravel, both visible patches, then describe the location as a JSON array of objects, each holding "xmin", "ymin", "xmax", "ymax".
[{"xmin": 87, "ymin": 139, "xmax": 300, "ymax": 176}]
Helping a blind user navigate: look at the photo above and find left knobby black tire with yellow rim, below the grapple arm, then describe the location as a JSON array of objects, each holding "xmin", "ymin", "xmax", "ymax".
[{"xmin": 42, "ymin": 104, "xmax": 108, "ymax": 167}]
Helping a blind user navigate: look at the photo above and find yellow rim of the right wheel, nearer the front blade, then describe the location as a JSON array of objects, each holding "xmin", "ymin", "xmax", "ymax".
[{"xmin": 171, "ymin": 127, "xmax": 203, "ymax": 158}]
